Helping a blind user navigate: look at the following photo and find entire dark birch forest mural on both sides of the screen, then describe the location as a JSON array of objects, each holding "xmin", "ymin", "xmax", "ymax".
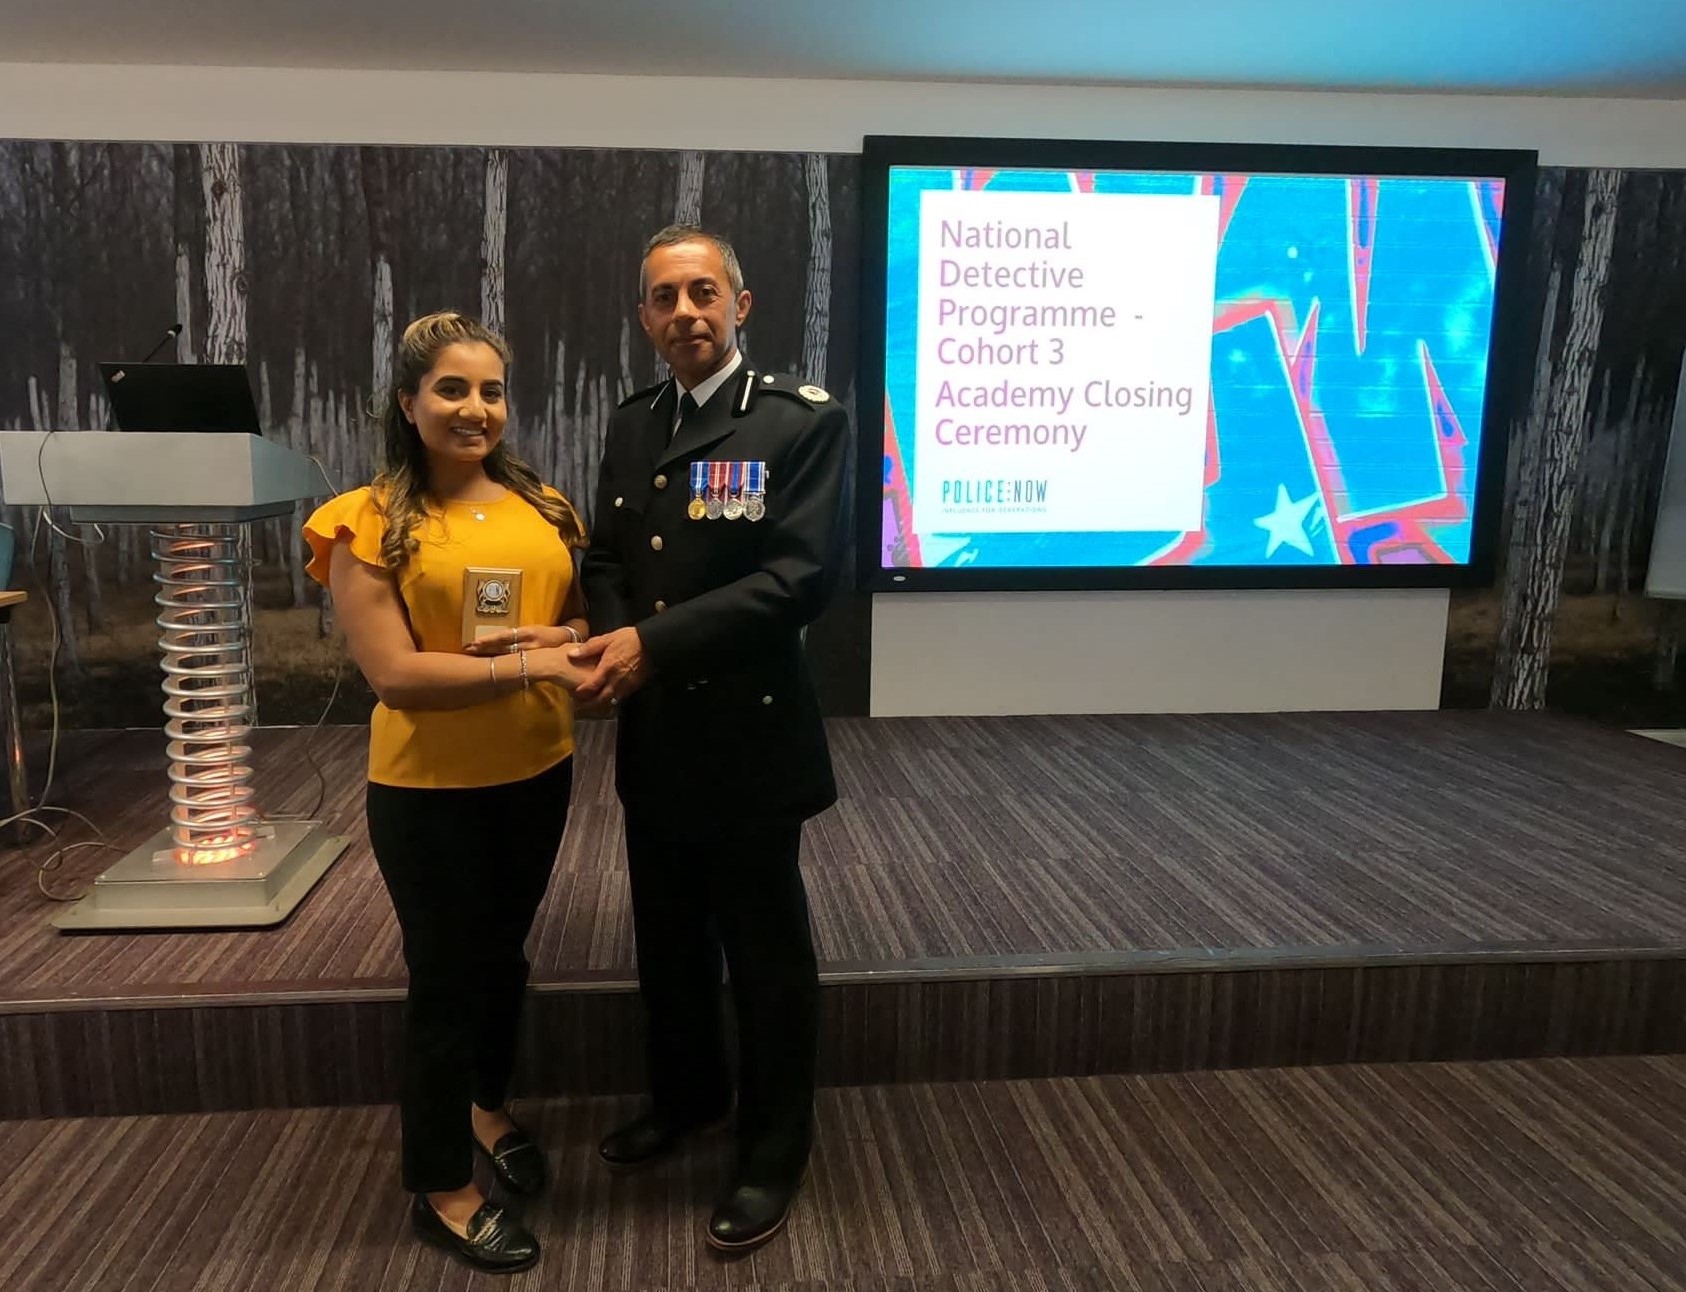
[{"xmin": 0, "ymin": 142, "xmax": 1686, "ymax": 727}]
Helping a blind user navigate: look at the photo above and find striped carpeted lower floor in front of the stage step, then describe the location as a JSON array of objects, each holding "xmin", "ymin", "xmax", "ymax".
[{"xmin": 0, "ymin": 1058, "xmax": 1686, "ymax": 1292}]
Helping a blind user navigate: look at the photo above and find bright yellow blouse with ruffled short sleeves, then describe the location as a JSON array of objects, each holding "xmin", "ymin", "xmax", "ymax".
[{"xmin": 303, "ymin": 487, "xmax": 573, "ymax": 789}]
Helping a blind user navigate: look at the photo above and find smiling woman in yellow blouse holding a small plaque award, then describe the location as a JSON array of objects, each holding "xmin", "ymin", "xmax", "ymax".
[{"xmin": 305, "ymin": 314, "xmax": 588, "ymax": 1272}]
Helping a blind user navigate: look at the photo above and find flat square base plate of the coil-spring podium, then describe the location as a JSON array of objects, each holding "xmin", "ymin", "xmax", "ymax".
[{"xmin": 52, "ymin": 821, "xmax": 351, "ymax": 931}]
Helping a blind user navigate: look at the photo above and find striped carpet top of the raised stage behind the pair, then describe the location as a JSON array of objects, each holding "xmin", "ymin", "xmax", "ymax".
[{"xmin": 0, "ymin": 713, "xmax": 1686, "ymax": 1007}]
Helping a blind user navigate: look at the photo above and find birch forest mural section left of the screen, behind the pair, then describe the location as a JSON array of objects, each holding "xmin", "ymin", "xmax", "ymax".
[{"xmin": 0, "ymin": 142, "xmax": 867, "ymax": 725}]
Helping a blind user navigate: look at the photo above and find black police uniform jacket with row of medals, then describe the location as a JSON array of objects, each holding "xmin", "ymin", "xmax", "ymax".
[{"xmin": 582, "ymin": 364, "xmax": 848, "ymax": 823}]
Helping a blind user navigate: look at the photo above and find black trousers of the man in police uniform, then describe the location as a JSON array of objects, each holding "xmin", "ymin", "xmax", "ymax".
[{"xmin": 627, "ymin": 815, "xmax": 819, "ymax": 1182}]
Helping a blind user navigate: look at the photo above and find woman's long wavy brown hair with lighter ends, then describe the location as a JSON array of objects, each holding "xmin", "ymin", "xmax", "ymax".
[{"xmin": 371, "ymin": 310, "xmax": 585, "ymax": 573}]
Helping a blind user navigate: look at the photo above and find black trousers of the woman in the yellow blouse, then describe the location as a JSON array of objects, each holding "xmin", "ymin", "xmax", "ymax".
[{"xmin": 368, "ymin": 759, "xmax": 573, "ymax": 1192}]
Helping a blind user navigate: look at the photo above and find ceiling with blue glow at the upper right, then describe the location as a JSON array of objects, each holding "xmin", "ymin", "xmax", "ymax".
[{"xmin": 0, "ymin": 0, "xmax": 1686, "ymax": 96}]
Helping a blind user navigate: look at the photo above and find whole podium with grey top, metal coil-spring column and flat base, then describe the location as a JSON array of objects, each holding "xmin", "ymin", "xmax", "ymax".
[{"xmin": 0, "ymin": 430, "xmax": 351, "ymax": 929}]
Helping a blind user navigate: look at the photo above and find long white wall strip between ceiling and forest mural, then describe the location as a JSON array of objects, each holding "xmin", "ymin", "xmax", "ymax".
[{"xmin": 0, "ymin": 62, "xmax": 1686, "ymax": 167}]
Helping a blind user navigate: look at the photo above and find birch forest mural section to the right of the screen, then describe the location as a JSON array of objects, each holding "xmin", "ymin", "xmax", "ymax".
[{"xmin": 1445, "ymin": 167, "xmax": 1686, "ymax": 725}]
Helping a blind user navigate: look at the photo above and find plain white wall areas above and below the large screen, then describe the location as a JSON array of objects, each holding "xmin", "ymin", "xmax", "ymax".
[{"xmin": 13, "ymin": 64, "xmax": 1686, "ymax": 713}]
